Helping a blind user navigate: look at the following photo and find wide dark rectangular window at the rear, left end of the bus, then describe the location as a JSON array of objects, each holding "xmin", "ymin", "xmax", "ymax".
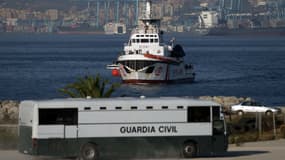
[{"xmin": 39, "ymin": 108, "xmax": 78, "ymax": 125}]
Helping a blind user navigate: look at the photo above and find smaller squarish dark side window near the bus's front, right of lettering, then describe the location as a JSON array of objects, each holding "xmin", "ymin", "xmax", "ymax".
[{"xmin": 187, "ymin": 107, "xmax": 210, "ymax": 122}]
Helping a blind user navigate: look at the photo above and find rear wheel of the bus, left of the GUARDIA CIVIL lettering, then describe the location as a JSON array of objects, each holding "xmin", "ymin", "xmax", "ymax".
[{"xmin": 80, "ymin": 143, "xmax": 99, "ymax": 160}]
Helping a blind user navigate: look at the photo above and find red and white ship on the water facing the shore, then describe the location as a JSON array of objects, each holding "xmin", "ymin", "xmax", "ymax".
[{"xmin": 107, "ymin": 0, "xmax": 195, "ymax": 83}]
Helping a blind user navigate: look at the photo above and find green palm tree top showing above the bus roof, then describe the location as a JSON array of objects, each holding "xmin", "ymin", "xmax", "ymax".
[{"xmin": 59, "ymin": 74, "xmax": 119, "ymax": 98}]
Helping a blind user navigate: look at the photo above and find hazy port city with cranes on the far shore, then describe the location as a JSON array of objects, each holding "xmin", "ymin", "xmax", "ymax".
[{"xmin": 0, "ymin": 0, "xmax": 285, "ymax": 33}]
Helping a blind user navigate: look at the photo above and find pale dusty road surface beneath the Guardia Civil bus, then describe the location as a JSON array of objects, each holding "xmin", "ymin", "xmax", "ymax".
[{"xmin": 0, "ymin": 139, "xmax": 285, "ymax": 160}]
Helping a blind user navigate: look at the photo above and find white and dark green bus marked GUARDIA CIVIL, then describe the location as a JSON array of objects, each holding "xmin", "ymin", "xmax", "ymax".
[{"xmin": 19, "ymin": 97, "xmax": 228, "ymax": 160}]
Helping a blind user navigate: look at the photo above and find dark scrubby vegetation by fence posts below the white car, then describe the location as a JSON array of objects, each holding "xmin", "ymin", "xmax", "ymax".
[{"xmin": 226, "ymin": 113, "xmax": 285, "ymax": 146}]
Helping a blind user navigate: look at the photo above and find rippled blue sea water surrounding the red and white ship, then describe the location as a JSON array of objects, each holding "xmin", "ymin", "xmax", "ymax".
[{"xmin": 0, "ymin": 34, "xmax": 285, "ymax": 105}]
